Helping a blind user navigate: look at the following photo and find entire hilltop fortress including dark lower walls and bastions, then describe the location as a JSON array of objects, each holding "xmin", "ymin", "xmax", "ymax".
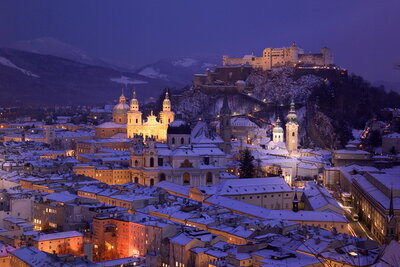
[{"xmin": 193, "ymin": 43, "xmax": 347, "ymax": 92}]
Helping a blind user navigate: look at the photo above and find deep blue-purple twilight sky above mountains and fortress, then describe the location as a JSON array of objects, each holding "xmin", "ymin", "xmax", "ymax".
[{"xmin": 0, "ymin": 0, "xmax": 400, "ymax": 86}]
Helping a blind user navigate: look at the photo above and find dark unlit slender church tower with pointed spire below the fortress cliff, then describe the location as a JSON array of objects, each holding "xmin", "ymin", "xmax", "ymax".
[{"xmin": 219, "ymin": 95, "xmax": 232, "ymax": 154}]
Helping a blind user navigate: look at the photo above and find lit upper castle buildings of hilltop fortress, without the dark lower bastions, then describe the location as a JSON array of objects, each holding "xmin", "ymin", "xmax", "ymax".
[{"xmin": 222, "ymin": 43, "xmax": 333, "ymax": 70}]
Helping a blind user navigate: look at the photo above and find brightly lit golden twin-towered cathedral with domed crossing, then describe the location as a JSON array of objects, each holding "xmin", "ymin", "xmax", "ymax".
[{"xmin": 96, "ymin": 91, "xmax": 175, "ymax": 142}]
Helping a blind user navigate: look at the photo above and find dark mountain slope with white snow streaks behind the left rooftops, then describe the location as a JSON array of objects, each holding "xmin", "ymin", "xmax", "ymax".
[{"xmin": 0, "ymin": 48, "xmax": 180, "ymax": 106}]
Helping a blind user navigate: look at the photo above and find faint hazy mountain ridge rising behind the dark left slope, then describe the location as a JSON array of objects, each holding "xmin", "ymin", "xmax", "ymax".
[{"xmin": 12, "ymin": 37, "xmax": 135, "ymax": 71}]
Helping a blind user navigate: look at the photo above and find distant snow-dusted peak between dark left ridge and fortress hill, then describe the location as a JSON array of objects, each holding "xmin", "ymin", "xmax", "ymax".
[{"xmin": 136, "ymin": 57, "xmax": 219, "ymax": 85}]
